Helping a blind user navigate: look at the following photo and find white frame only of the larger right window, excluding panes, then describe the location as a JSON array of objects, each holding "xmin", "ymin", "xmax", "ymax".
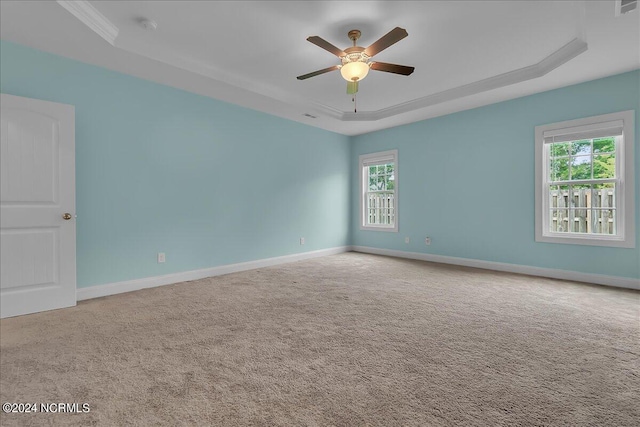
[{"xmin": 535, "ymin": 110, "xmax": 635, "ymax": 248}]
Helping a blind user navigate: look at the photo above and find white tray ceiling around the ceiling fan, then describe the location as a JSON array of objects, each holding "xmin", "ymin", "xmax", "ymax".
[{"xmin": 0, "ymin": 0, "xmax": 640, "ymax": 135}]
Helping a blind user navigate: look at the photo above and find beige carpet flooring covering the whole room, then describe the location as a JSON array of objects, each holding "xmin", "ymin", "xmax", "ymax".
[{"xmin": 0, "ymin": 253, "xmax": 640, "ymax": 426}]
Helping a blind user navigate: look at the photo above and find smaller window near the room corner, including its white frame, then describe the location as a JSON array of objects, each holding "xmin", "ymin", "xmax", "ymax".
[{"xmin": 360, "ymin": 150, "xmax": 398, "ymax": 231}]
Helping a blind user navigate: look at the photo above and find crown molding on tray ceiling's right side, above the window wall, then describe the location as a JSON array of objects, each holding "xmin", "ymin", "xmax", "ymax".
[{"xmin": 314, "ymin": 38, "xmax": 588, "ymax": 122}]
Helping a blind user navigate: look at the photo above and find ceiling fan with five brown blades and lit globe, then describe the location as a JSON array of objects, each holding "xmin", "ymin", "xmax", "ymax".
[{"xmin": 297, "ymin": 27, "xmax": 415, "ymax": 99}]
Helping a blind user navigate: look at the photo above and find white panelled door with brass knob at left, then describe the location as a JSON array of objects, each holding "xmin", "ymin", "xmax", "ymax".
[{"xmin": 0, "ymin": 94, "xmax": 76, "ymax": 318}]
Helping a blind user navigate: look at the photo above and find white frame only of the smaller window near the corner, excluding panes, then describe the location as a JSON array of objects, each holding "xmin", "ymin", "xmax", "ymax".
[{"xmin": 359, "ymin": 150, "xmax": 399, "ymax": 233}]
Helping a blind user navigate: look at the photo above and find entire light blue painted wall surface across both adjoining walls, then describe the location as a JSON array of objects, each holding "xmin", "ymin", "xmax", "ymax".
[{"xmin": 0, "ymin": 42, "xmax": 640, "ymax": 287}]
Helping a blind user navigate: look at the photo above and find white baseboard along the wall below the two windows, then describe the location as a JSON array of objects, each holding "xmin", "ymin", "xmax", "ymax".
[{"xmin": 351, "ymin": 246, "xmax": 640, "ymax": 290}]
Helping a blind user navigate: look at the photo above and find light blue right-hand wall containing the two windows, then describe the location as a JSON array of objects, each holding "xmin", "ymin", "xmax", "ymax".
[{"xmin": 351, "ymin": 71, "xmax": 640, "ymax": 278}]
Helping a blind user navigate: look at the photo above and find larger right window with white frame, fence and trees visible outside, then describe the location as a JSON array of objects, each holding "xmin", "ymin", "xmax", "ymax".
[{"xmin": 535, "ymin": 111, "xmax": 635, "ymax": 248}]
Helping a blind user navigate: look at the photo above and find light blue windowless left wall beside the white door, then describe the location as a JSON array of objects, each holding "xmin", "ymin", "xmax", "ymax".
[{"xmin": 0, "ymin": 42, "xmax": 350, "ymax": 287}]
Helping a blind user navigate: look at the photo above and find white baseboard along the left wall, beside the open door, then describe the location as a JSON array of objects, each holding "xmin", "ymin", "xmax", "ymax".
[{"xmin": 76, "ymin": 246, "xmax": 351, "ymax": 301}]
